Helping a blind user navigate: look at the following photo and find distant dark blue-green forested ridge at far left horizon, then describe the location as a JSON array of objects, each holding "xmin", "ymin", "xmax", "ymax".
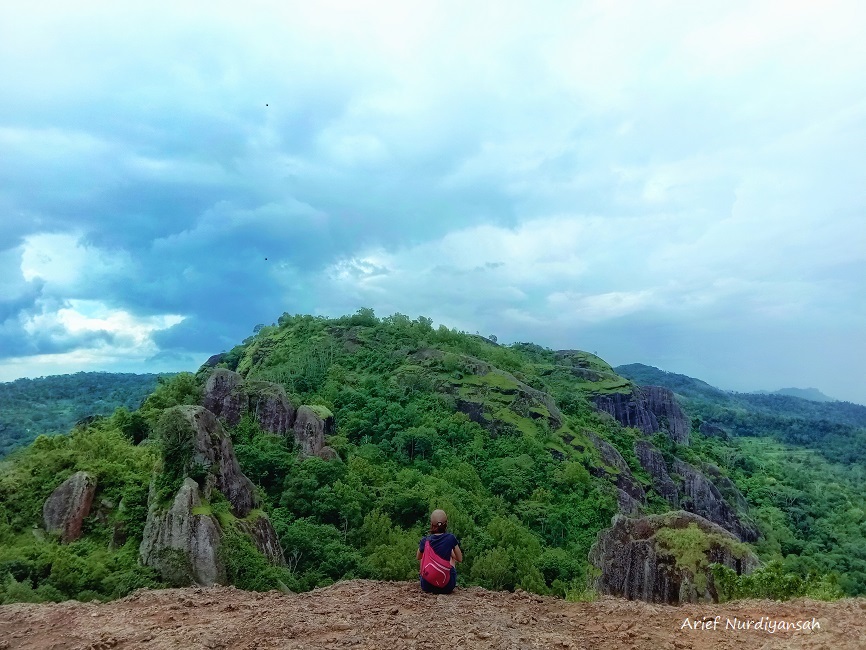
[{"xmin": 0, "ymin": 372, "xmax": 165, "ymax": 458}]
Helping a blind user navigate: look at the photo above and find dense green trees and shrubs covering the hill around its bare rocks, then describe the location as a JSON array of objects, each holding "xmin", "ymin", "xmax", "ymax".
[{"xmin": 0, "ymin": 309, "xmax": 866, "ymax": 602}]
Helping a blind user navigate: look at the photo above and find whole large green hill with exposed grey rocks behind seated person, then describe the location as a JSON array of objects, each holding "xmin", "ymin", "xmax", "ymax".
[{"xmin": 0, "ymin": 309, "xmax": 866, "ymax": 603}]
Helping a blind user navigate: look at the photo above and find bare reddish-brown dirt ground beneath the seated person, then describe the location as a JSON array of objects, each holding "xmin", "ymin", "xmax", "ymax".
[{"xmin": 0, "ymin": 580, "xmax": 866, "ymax": 650}]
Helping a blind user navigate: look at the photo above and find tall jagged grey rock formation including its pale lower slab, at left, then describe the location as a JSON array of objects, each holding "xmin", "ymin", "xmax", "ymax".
[{"xmin": 139, "ymin": 406, "xmax": 285, "ymax": 585}]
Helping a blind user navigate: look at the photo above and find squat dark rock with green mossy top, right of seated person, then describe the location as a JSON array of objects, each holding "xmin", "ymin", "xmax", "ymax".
[{"xmin": 589, "ymin": 511, "xmax": 758, "ymax": 604}]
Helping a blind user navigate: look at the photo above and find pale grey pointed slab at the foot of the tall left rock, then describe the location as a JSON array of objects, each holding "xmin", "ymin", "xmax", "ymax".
[{"xmin": 139, "ymin": 478, "xmax": 226, "ymax": 586}]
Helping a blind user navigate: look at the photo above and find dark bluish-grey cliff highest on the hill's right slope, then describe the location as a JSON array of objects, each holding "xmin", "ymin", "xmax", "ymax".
[{"xmin": 592, "ymin": 386, "xmax": 690, "ymax": 445}]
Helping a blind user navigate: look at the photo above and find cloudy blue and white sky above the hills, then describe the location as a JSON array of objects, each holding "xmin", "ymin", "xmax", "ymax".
[{"xmin": 0, "ymin": 0, "xmax": 866, "ymax": 404}]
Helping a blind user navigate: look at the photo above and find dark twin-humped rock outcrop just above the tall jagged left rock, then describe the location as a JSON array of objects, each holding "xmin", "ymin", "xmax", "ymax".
[{"xmin": 202, "ymin": 368, "xmax": 295, "ymax": 434}]
